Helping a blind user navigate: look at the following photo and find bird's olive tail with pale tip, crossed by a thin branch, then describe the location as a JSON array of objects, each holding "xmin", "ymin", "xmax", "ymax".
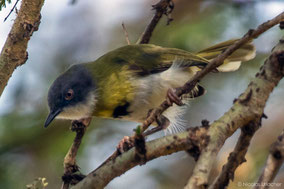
[{"xmin": 196, "ymin": 39, "xmax": 255, "ymax": 72}]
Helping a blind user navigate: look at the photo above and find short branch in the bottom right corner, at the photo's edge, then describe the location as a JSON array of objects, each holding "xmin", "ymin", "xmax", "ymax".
[{"xmin": 254, "ymin": 130, "xmax": 284, "ymax": 189}]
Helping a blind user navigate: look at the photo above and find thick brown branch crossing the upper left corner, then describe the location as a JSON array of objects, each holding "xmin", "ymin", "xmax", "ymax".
[{"xmin": 0, "ymin": 0, "xmax": 44, "ymax": 96}]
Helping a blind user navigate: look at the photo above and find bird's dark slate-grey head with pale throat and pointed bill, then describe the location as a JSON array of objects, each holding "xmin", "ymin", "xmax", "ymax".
[{"xmin": 44, "ymin": 64, "xmax": 95, "ymax": 127}]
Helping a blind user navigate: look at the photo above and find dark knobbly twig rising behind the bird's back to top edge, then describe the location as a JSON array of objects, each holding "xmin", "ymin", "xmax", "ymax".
[{"xmin": 137, "ymin": 0, "xmax": 174, "ymax": 44}]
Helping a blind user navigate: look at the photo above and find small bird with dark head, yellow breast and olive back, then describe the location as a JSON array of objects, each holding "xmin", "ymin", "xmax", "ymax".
[{"xmin": 44, "ymin": 39, "xmax": 255, "ymax": 132}]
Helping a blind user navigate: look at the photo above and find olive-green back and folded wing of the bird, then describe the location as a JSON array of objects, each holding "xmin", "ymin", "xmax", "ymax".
[{"xmin": 96, "ymin": 44, "xmax": 208, "ymax": 77}]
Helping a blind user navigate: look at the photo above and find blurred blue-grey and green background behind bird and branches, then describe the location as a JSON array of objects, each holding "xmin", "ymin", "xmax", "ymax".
[{"xmin": 0, "ymin": 0, "xmax": 284, "ymax": 189}]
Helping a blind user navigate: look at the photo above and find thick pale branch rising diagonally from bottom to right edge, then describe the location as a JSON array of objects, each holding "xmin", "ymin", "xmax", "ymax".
[{"xmin": 186, "ymin": 35, "xmax": 284, "ymax": 188}]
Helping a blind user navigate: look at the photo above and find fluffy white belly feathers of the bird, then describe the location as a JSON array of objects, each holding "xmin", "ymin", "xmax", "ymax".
[{"xmin": 126, "ymin": 66, "xmax": 193, "ymax": 125}]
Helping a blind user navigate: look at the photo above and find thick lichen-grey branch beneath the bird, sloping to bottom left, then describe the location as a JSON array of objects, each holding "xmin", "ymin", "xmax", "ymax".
[{"xmin": 72, "ymin": 127, "xmax": 208, "ymax": 189}]
